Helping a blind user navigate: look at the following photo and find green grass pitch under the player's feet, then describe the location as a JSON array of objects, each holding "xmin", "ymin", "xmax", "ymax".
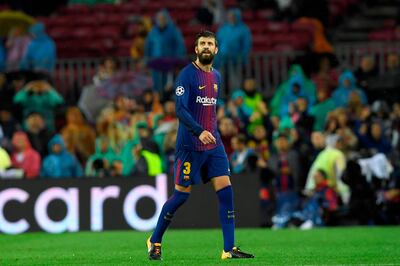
[{"xmin": 0, "ymin": 227, "xmax": 400, "ymax": 266}]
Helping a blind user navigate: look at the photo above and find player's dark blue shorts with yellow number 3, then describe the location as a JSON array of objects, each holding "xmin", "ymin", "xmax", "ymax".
[{"xmin": 174, "ymin": 145, "xmax": 231, "ymax": 187}]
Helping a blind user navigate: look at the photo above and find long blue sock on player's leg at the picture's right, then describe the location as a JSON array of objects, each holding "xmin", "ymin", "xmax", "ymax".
[{"xmin": 217, "ymin": 186, "xmax": 235, "ymax": 252}]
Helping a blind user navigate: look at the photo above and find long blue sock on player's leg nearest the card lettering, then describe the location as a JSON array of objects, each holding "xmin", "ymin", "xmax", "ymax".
[{"xmin": 150, "ymin": 190, "xmax": 190, "ymax": 243}]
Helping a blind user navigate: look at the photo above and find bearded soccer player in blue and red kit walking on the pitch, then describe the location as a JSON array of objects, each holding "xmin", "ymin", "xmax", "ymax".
[{"xmin": 147, "ymin": 31, "xmax": 254, "ymax": 260}]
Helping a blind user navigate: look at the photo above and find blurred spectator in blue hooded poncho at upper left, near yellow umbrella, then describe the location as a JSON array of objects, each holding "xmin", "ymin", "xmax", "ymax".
[{"xmin": 21, "ymin": 23, "xmax": 57, "ymax": 73}]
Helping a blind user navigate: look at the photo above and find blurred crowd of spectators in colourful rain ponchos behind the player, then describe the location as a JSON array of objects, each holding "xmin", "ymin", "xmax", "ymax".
[{"xmin": 0, "ymin": 1, "xmax": 400, "ymax": 228}]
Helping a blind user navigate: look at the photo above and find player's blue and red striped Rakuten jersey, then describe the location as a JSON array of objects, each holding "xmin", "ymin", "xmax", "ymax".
[{"xmin": 175, "ymin": 62, "xmax": 222, "ymax": 151}]
